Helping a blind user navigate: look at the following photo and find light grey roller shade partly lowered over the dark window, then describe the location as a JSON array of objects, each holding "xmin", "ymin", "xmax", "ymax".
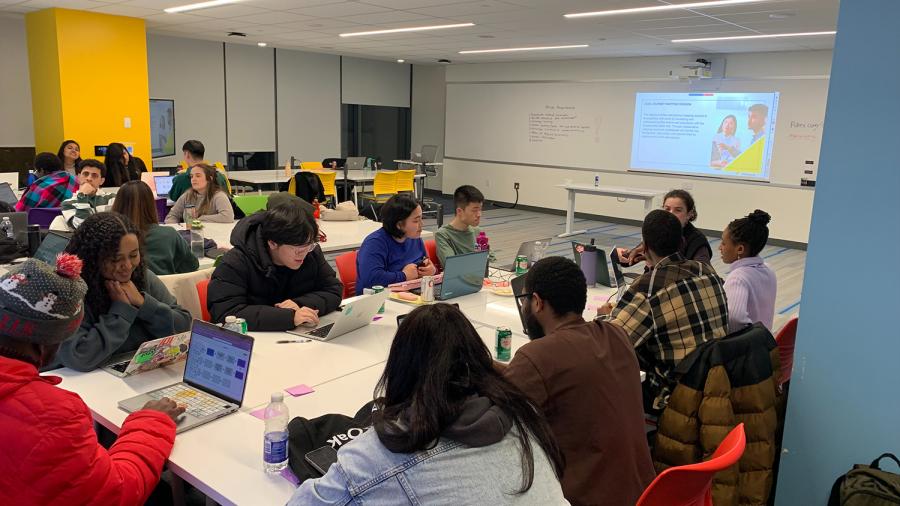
[{"xmin": 341, "ymin": 56, "xmax": 410, "ymax": 107}]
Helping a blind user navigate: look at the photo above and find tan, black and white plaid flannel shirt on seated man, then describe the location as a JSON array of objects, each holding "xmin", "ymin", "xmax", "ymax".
[{"xmin": 604, "ymin": 253, "xmax": 728, "ymax": 406}]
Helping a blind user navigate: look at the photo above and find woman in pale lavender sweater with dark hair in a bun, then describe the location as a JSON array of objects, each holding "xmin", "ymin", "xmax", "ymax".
[{"xmin": 719, "ymin": 209, "xmax": 778, "ymax": 332}]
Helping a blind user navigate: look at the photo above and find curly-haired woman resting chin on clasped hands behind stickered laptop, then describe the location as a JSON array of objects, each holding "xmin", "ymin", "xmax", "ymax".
[{"xmin": 59, "ymin": 212, "xmax": 191, "ymax": 371}]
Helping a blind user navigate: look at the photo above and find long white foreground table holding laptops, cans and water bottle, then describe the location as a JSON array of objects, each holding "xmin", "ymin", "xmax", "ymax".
[{"xmin": 45, "ymin": 266, "xmax": 624, "ymax": 505}]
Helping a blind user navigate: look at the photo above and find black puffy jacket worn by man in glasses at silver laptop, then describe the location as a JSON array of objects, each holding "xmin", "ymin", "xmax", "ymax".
[{"xmin": 207, "ymin": 213, "xmax": 343, "ymax": 331}]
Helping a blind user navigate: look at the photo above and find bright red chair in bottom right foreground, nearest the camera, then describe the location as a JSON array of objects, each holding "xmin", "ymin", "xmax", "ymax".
[{"xmin": 637, "ymin": 424, "xmax": 747, "ymax": 506}]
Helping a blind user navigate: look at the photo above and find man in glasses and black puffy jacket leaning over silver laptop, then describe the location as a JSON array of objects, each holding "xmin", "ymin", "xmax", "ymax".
[{"xmin": 207, "ymin": 203, "xmax": 343, "ymax": 331}]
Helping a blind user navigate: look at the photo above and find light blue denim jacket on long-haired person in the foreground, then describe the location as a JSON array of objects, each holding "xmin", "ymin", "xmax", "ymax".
[{"xmin": 288, "ymin": 430, "xmax": 569, "ymax": 506}]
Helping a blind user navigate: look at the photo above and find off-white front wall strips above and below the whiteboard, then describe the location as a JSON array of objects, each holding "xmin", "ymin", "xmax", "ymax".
[{"xmin": 442, "ymin": 51, "xmax": 831, "ymax": 242}]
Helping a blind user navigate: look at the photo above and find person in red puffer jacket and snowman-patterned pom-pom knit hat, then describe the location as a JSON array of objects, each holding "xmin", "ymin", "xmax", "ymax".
[{"xmin": 0, "ymin": 255, "xmax": 184, "ymax": 504}]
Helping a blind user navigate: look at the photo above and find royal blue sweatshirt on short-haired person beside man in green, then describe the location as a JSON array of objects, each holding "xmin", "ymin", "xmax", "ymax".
[{"xmin": 356, "ymin": 228, "xmax": 425, "ymax": 295}]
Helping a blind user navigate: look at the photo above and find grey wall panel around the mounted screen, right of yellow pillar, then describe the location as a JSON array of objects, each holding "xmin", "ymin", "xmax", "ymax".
[{"xmin": 147, "ymin": 35, "xmax": 228, "ymax": 167}]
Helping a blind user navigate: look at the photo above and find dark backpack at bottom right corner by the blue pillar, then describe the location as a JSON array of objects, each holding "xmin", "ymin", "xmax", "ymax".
[{"xmin": 828, "ymin": 453, "xmax": 900, "ymax": 506}]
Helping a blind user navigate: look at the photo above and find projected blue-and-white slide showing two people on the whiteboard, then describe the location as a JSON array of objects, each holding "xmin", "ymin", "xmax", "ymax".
[{"xmin": 631, "ymin": 93, "xmax": 778, "ymax": 181}]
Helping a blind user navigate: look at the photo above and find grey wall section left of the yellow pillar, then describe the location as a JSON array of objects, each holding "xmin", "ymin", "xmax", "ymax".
[{"xmin": 0, "ymin": 14, "xmax": 33, "ymax": 147}]
